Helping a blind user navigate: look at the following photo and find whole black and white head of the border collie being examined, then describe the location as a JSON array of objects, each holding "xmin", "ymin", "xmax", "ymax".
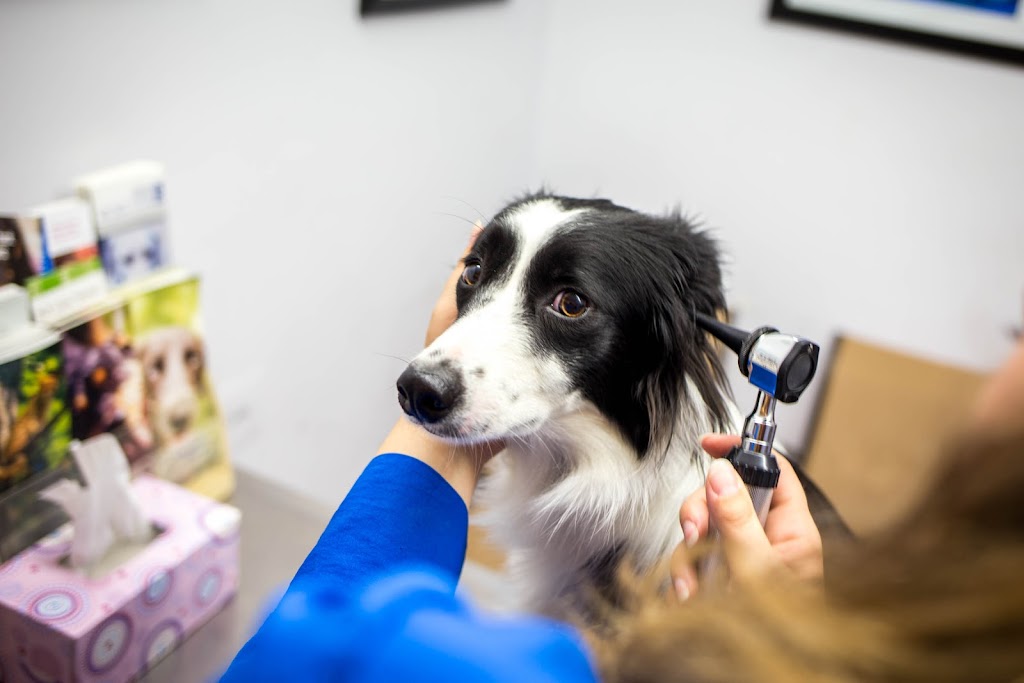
[{"xmin": 398, "ymin": 195, "xmax": 727, "ymax": 456}]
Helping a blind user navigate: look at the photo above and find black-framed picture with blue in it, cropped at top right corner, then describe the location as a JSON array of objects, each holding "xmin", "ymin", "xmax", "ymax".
[{"xmin": 770, "ymin": 0, "xmax": 1024, "ymax": 63}]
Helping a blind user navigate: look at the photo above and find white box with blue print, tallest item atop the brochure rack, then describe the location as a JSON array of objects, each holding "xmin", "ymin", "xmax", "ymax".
[{"xmin": 75, "ymin": 161, "xmax": 170, "ymax": 285}]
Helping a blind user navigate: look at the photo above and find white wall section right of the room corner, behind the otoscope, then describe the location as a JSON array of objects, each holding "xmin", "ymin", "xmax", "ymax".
[{"xmin": 537, "ymin": 0, "xmax": 1024, "ymax": 442}]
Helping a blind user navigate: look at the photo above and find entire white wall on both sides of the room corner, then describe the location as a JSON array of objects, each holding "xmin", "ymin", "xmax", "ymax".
[{"xmin": 0, "ymin": 0, "xmax": 1024, "ymax": 503}]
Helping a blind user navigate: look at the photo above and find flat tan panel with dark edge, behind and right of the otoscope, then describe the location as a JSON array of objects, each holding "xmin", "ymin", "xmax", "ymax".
[{"xmin": 804, "ymin": 337, "xmax": 985, "ymax": 535}]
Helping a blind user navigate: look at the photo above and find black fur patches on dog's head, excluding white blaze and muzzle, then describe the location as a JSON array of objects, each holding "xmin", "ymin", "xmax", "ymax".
[{"xmin": 458, "ymin": 194, "xmax": 728, "ymax": 456}]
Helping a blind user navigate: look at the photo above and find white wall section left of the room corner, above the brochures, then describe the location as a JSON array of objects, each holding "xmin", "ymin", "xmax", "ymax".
[{"xmin": 0, "ymin": 0, "xmax": 541, "ymax": 504}]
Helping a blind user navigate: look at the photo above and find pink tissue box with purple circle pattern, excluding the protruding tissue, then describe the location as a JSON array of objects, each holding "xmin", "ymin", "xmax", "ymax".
[{"xmin": 0, "ymin": 476, "xmax": 241, "ymax": 683}]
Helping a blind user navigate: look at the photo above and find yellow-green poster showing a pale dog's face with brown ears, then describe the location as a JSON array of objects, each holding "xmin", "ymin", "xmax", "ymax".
[{"xmin": 124, "ymin": 273, "xmax": 234, "ymax": 499}]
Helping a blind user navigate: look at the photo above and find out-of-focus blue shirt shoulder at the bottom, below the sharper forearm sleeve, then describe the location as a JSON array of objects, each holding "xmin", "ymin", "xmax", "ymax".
[{"xmin": 222, "ymin": 567, "xmax": 597, "ymax": 683}]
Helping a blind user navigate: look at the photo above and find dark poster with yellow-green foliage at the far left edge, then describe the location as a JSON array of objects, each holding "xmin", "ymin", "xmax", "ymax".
[{"xmin": 0, "ymin": 335, "xmax": 72, "ymax": 561}]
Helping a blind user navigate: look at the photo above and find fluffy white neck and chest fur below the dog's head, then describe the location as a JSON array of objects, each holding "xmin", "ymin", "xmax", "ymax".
[{"xmin": 480, "ymin": 386, "xmax": 713, "ymax": 617}]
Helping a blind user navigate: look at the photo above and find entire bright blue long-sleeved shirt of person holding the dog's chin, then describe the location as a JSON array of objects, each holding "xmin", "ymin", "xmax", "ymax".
[{"xmin": 221, "ymin": 454, "xmax": 596, "ymax": 683}]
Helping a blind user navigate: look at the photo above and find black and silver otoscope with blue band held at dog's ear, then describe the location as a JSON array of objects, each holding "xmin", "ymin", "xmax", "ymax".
[{"xmin": 696, "ymin": 313, "xmax": 819, "ymax": 574}]
